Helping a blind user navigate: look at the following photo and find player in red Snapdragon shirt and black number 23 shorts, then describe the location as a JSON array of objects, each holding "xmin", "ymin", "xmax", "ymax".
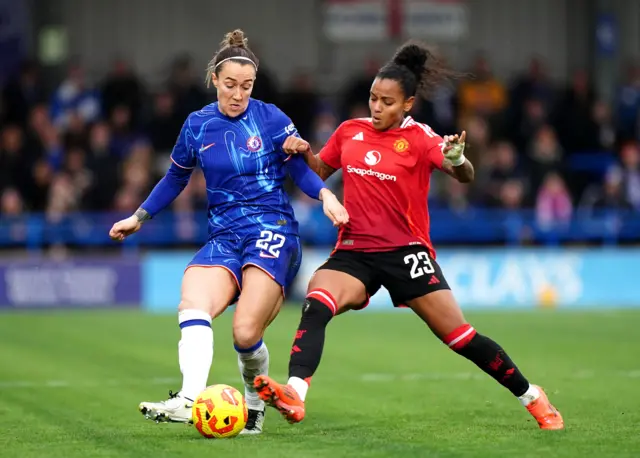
[{"xmin": 255, "ymin": 42, "xmax": 564, "ymax": 429}]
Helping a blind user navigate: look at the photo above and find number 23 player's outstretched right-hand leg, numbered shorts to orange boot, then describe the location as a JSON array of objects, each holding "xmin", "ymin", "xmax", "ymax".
[{"xmin": 389, "ymin": 249, "xmax": 563, "ymax": 429}]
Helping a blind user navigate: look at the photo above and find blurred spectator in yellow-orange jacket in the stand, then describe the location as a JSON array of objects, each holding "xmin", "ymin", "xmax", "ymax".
[{"xmin": 458, "ymin": 55, "xmax": 507, "ymax": 128}]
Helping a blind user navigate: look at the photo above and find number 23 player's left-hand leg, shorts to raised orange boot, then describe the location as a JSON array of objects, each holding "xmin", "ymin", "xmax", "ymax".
[{"xmin": 255, "ymin": 253, "xmax": 377, "ymax": 423}]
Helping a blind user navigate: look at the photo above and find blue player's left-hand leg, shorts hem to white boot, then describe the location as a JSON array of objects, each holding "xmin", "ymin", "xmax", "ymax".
[{"xmin": 139, "ymin": 244, "xmax": 240, "ymax": 422}]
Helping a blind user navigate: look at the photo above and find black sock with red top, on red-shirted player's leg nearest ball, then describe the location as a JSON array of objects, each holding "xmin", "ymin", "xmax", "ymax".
[{"xmin": 289, "ymin": 291, "xmax": 334, "ymax": 379}]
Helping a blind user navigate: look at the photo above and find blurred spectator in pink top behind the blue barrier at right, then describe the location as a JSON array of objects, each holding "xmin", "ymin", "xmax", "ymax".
[{"xmin": 536, "ymin": 172, "xmax": 573, "ymax": 231}]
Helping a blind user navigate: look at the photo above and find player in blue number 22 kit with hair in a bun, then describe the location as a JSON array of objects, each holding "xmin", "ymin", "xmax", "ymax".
[{"xmin": 110, "ymin": 30, "xmax": 348, "ymax": 434}]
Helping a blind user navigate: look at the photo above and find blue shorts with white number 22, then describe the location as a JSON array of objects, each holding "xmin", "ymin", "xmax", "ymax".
[{"xmin": 187, "ymin": 230, "xmax": 302, "ymax": 291}]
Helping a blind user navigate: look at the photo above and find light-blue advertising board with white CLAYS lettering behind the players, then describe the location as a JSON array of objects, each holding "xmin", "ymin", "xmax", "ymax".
[{"xmin": 142, "ymin": 248, "xmax": 640, "ymax": 311}]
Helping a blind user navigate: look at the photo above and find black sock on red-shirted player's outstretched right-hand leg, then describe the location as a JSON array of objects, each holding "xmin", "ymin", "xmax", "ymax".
[{"xmin": 445, "ymin": 325, "xmax": 529, "ymax": 396}]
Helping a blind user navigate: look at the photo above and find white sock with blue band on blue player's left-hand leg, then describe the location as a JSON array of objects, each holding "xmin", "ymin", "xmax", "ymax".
[{"xmin": 178, "ymin": 310, "xmax": 213, "ymax": 400}]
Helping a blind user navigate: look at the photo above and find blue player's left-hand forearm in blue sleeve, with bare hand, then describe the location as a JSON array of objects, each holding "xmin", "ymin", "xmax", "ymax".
[{"xmin": 109, "ymin": 163, "xmax": 193, "ymax": 242}]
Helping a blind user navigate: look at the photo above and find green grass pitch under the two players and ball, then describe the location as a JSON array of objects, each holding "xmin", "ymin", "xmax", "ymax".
[{"xmin": 0, "ymin": 307, "xmax": 640, "ymax": 458}]
